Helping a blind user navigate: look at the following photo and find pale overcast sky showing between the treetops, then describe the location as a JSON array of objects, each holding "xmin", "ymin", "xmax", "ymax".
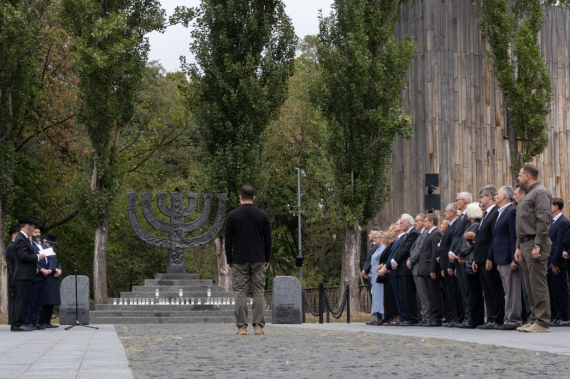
[{"xmin": 149, "ymin": 0, "xmax": 333, "ymax": 71}]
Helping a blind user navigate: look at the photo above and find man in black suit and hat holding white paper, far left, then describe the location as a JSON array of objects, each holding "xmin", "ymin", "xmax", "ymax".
[{"xmin": 12, "ymin": 216, "xmax": 45, "ymax": 332}]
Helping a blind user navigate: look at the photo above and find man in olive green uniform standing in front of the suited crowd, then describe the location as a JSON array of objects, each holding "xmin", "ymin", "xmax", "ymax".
[{"xmin": 515, "ymin": 164, "xmax": 552, "ymax": 333}]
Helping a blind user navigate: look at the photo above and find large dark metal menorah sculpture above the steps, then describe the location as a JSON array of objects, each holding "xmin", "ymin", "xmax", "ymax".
[{"xmin": 127, "ymin": 192, "xmax": 227, "ymax": 274}]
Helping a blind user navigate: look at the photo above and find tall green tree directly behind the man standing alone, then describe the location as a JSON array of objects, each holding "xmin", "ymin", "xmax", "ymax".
[{"xmin": 185, "ymin": 0, "xmax": 296, "ymax": 288}]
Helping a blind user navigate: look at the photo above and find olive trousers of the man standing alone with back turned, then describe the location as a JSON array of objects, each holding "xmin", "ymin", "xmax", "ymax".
[{"xmin": 234, "ymin": 262, "xmax": 265, "ymax": 328}]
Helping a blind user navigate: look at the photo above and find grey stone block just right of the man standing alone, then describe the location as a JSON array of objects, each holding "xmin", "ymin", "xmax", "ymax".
[{"xmin": 272, "ymin": 276, "xmax": 303, "ymax": 324}]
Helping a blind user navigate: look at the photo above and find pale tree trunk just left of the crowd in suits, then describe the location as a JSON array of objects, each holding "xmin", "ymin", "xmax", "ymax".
[{"xmin": 340, "ymin": 225, "xmax": 362, "ymax": 312}]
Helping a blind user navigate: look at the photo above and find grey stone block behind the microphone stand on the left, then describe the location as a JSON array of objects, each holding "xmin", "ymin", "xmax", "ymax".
[{"xmin": 59, "ymin": 275, "xmax": 89, "ymax": 325}]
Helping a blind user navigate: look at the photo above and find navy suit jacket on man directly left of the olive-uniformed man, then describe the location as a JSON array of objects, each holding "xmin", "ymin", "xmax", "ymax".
[{"xmin": 491, "ymin": 204, "xmax": 517, "ymax": 265}]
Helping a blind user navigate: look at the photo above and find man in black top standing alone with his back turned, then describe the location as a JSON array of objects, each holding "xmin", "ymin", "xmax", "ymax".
[{"xmin": 225, "ymin": 185, "xmax": 271, "ymax": 335}]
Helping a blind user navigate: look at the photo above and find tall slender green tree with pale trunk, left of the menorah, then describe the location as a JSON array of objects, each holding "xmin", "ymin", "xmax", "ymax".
[{"xmin": 62, "ymin": 0, "xmax": 164, "ymax": 303}]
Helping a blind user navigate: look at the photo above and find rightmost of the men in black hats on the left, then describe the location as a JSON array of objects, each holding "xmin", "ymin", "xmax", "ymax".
[{"xmin": 39, "ymin": 232, "xmax": 62, "ymax": 329}]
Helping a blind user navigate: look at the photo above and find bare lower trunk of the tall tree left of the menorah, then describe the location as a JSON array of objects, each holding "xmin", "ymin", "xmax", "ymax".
[{"xmin": 93, "ymin": 215, "xmax": 109, "ymax": 304}]
